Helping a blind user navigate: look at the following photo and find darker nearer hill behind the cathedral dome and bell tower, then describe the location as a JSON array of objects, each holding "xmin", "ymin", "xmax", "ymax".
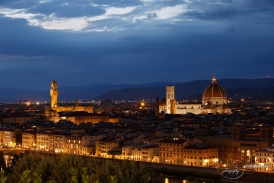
[{"xmin": 95, "ymin": 78, "xmax": 274, "ymax": 100}]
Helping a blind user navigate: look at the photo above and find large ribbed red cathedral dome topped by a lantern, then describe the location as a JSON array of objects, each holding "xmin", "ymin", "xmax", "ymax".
[{"xmin": 202, "ymin": 75, "xmax": 227, "ymax": 105}]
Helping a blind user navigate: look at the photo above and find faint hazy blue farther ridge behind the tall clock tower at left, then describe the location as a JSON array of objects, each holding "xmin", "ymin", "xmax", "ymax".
[{"xmin": 0, "ymin": 82, "xmax": 176, "ymax": 102}]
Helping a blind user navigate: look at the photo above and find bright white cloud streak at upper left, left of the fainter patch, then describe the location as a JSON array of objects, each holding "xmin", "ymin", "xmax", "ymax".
[{"xmin": 0, "ymin": 1, "xmax": 137, "ymax": 32}]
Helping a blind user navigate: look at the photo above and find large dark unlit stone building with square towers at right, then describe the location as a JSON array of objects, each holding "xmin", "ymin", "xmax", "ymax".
[{"xmin": 200, "ymin": 124, "xmax": 273, "ymax": 163}]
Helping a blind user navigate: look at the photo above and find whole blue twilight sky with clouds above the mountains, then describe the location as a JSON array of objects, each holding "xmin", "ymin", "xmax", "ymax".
[{"xmin": 0, "ymin": 0, "xmax": 274, "ymax": 90}]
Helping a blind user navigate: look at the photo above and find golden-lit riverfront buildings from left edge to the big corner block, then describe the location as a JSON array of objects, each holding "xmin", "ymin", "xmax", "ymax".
[{"xmin": 0, "ymin": 127, "xmax": 218, "ymax": 167}]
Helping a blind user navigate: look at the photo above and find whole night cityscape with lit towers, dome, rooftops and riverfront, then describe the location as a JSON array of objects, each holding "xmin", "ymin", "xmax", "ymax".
[{"xmin": 0, "ymin": 75, "xmax": 274, "ymax": 181}]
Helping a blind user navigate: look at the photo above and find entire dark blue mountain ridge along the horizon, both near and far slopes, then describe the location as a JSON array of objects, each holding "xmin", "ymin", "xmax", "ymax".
[{"xmin": 0, "ymin": 78, "xmax": 274, "ymax": 102}]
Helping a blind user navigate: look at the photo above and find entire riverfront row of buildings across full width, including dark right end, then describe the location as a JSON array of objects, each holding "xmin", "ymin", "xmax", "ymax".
[{"xmin": 0, "ymin": 124, "xmax": 274, "ymax": 172}]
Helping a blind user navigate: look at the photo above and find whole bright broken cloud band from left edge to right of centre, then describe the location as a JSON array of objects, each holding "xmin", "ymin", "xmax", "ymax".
[{"xmin": 0, "ymin": 0, "xmax": 193, "ymax": 32}]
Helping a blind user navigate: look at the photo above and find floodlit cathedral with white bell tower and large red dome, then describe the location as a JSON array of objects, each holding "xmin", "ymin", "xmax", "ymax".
[{"xmin": 159, "ymin": 75, "xmax": 231, "ymax": 114}]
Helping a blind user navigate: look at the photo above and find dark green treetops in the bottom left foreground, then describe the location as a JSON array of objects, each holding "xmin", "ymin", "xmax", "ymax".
[{"xmin": 4, "ymin": 153, "xmax": 163, "ymax": 183}]
